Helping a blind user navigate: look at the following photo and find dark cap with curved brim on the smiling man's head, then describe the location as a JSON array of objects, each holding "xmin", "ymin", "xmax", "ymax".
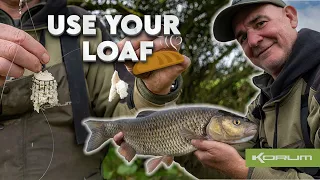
[{"xmin": 213, "ymin": 0, "xmax": 286, "ymax": 42}]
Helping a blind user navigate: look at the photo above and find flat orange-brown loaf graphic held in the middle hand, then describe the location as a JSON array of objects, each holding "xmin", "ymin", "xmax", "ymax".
[{"xmin": 133, "ymin": 51, "xmax": 184, "ymax": 75}]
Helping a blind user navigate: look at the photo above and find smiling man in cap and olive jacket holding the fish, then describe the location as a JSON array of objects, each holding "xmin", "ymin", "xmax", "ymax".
[{"xmin": 114, "ymin": 0, "xmax": 320, "ymax": 179}]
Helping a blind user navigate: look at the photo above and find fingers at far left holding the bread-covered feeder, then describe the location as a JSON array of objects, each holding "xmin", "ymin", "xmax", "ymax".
[{"xmin": 0, "ymin": 23, "xmax": 50, "ymax": 86}]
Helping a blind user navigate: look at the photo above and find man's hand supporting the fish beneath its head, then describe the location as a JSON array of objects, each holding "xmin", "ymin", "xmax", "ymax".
[{"xmin": 191, "ymin": 140, "xmax": 249, "ymax": 179}]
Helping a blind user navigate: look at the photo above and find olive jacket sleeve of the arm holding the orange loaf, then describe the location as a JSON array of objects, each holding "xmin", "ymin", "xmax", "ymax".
[{"xmin": 80, "ymin": 19, "xmax": 182, "ymax": 117}]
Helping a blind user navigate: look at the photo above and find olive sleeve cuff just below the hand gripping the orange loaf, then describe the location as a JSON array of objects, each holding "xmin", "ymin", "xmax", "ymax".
[{"xmin": 133, "ymin": 75, "xmax": 182, "ymax": 108}]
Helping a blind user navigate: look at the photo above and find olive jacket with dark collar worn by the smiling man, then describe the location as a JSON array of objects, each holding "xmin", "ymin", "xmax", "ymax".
[{"xmin": 175, "ymin": 29, "xmax": 320, "ymax": 179}]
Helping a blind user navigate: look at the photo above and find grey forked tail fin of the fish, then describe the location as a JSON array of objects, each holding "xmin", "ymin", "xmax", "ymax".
[{"xmin": 84, "ymin": 120, "xmax": 117, "ymax": 153}]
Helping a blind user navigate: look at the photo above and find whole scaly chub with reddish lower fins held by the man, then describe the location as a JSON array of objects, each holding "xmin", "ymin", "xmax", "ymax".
[{"xmin": 84, "ymin": 106, "xmax": 257, "ymax": 172}]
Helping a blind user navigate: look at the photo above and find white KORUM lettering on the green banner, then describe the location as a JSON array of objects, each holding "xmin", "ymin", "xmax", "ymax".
[{"xmin": 252, "ymin": 152, "xmax": 312, "ymax": 163}]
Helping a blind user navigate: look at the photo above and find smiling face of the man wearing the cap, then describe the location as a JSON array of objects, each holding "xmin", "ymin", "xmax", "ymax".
[{"xmin": 232, "ymin": 4, "xmax": 298, "ymax": 79}]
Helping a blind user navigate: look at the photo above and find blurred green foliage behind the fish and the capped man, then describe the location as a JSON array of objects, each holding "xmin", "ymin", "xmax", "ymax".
[{"xmin": 68, "ymin": 0, "xmax": 258, "ymax": 179}]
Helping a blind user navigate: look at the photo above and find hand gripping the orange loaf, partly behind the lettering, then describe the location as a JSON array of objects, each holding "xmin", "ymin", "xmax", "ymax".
[{"xmin": 118, "ymin": 33, "xmax": 190, "ymax": 95}]
